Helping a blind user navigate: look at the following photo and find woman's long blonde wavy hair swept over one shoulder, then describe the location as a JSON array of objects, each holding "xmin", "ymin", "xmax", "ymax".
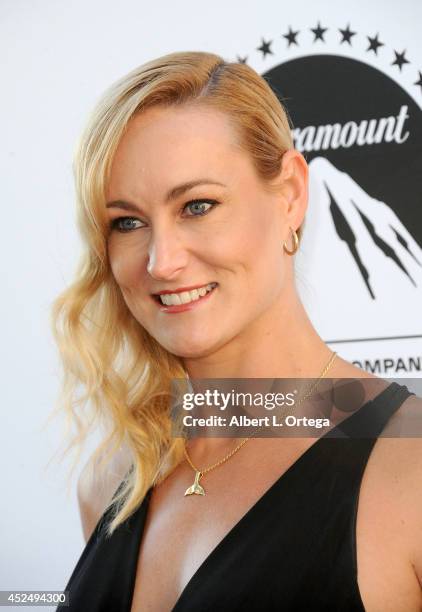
[{"xmin": 51, "ymin": 52, "xmax": 301, "ymax": 536}]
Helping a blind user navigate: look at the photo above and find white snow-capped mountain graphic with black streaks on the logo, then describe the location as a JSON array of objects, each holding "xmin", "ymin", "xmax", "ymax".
[{"xmin": 295, "ymin": 157, "xmax": 422, "ymax": 338}]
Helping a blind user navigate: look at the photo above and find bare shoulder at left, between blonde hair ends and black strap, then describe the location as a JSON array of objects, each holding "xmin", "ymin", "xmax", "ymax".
[{"xmin": 77, "ymin": 440, "xmax": 131, "ymax": 541}]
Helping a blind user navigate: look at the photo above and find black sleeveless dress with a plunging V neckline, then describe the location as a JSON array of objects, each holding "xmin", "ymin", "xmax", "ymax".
[{"xmin": 57, "ymin": 382, "xmax": 414, "ymax": 612}]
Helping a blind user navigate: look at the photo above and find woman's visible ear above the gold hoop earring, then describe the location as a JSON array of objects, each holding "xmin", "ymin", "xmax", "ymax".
[{"xmin": 279, "ymin": 149, "xmax": 308, "ymax": 240}]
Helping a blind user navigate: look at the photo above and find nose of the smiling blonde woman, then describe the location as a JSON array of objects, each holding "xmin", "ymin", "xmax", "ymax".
[{"xmin": 147, "ymin": 228, "xmax": 187, "ymax": 280}]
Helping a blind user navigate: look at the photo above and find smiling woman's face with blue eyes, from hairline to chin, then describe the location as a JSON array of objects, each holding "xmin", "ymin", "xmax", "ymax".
[{"xmin": 107, "ymin": 106, "xmax": 300, "ymax": 358}]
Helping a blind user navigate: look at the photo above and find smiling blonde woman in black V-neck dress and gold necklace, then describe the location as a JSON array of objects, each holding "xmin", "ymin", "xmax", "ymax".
[{"xmin": 53, "ymin": 52, "xmax": 422, "ymax": 612}]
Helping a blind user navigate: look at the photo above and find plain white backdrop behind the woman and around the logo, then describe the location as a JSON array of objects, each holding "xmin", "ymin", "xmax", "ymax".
[{"xmin": 0, "ymin": 0, "xmax": 422, "ymax": 609}]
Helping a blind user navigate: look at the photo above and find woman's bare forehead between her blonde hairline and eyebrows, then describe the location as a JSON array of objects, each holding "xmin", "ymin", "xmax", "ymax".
[{"xmin": 107, "ymin": 106, "xmax": 251, "ymax": 197}]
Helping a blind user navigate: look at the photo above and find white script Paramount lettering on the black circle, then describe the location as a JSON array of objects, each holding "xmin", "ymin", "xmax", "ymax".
[{"xmin": 292, "ymin": 105, "xmax": 409, "ymax": 152}]
